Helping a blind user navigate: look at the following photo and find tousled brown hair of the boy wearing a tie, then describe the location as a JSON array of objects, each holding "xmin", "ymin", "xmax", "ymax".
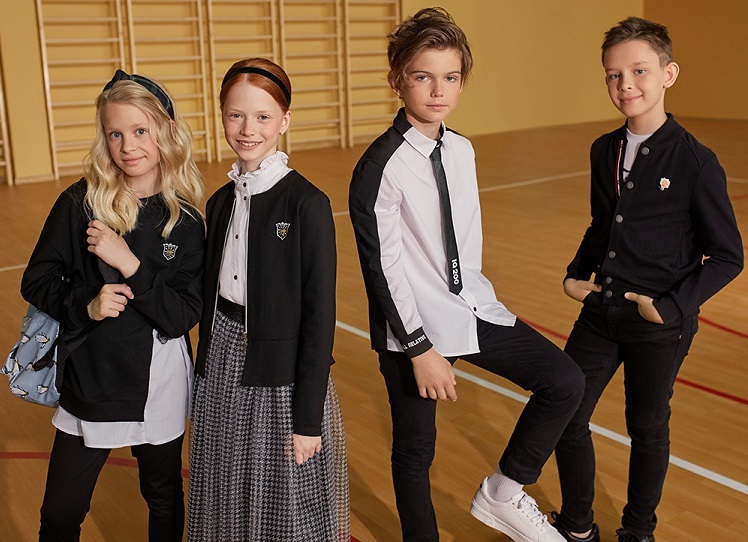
[{"xmin": 387, "ymin": 8, "xmax": 473, "ymax": 88}]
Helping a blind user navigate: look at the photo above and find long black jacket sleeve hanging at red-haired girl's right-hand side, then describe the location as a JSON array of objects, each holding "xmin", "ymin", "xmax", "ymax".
[{"xmin": 293, "ymin": 192, "xmax": 336, "ymax": 436}]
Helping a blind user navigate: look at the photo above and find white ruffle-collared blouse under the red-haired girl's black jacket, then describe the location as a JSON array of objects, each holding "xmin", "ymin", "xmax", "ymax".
[{"xmin": 218, "ymin": 151, "xmax": 291, "ymax": 306}]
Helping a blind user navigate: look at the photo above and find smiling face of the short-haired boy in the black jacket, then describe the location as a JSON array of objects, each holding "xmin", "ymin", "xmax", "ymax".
[{"xmin": 603, "ymin": 39, "xmax": 678, "ymax": 135}]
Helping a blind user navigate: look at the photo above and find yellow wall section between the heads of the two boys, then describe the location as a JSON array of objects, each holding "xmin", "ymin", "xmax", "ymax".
[{"xmin": 402, "ymin": 0, "xmax": 644, "ymax": 135}]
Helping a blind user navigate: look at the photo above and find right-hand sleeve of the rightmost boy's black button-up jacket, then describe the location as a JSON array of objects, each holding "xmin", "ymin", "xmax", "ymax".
[{"xmin": 655, "ymin": 156, "xmax": 743, "ymax": 322}]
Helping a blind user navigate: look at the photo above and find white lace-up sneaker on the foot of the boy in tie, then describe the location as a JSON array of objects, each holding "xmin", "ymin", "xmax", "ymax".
[{"xmin": 470, "ymin": 480, "xmax": 566, "ymax": 542}]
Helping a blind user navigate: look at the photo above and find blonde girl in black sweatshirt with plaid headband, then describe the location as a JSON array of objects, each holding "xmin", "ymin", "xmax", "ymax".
[{"xmin": 21, "ymin": 70, "xmax": 204, "ymax": 541}]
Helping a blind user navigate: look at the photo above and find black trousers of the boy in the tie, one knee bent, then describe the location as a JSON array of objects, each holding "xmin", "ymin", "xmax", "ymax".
[{"xmin": 378, "ymin": 320, "xmax": 584, "ymax": 541}]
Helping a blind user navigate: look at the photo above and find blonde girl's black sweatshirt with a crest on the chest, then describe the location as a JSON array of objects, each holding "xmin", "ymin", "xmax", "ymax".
[{"xmin": 21, "ymin": 179, "xmax": 204, "ymax": 422}]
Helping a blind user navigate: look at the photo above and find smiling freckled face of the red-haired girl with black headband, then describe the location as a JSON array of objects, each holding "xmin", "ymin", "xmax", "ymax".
[{"xmin": 222, "ymin": 83, "xmax": 291, "ymax": 173}]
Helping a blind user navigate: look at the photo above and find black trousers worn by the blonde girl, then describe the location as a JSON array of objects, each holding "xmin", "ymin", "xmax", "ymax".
[{"xmin": 39, "ymin": 430, "xmax": 184, "ymax": 542}]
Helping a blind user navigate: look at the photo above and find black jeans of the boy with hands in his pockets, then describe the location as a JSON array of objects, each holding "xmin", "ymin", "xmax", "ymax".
[{"xmin": 556, "ymin": 293, "xmax": 698, "ymax": 535}]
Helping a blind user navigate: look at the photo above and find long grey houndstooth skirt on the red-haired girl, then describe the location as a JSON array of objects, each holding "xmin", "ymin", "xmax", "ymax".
[{"xmin": 187, "ymin": 312, "xmax": 351, "ymax": 542}]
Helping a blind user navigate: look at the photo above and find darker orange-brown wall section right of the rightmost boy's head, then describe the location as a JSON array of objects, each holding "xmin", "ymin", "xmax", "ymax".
[{"xmin": 644, "ymin": 0, "xmax": 748, "ymax": 120}]
